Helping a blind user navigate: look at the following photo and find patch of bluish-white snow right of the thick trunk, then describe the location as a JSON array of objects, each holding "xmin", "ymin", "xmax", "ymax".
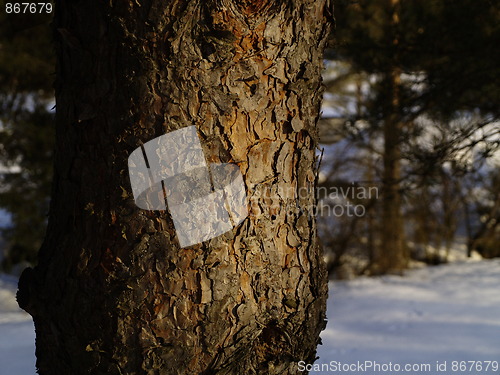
[{"xmin": 312, "ymin": 259, "xmax": 500, "ymax": 374}]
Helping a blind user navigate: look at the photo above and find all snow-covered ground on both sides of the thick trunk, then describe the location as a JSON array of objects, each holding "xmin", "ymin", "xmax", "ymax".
[{"xmin": 0, "ymin": 259, "xmax": 500, "ymax": 375}]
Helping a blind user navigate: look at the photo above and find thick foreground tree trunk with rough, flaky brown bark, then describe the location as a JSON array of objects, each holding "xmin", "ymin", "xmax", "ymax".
[{"xmin": 18, "ymin": 0, "xmax": 331, "ymax": 375}]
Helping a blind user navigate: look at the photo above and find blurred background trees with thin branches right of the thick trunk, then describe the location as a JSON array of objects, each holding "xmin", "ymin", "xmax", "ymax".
[{"xmin": 320, "ymin": 0, "xmax": 500, "ymax": 275}]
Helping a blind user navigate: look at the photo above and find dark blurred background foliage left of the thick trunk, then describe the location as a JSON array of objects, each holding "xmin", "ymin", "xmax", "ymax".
[{"xmin": 0, "ymin": 11, "xmax": 55, "ymax": 271}]
